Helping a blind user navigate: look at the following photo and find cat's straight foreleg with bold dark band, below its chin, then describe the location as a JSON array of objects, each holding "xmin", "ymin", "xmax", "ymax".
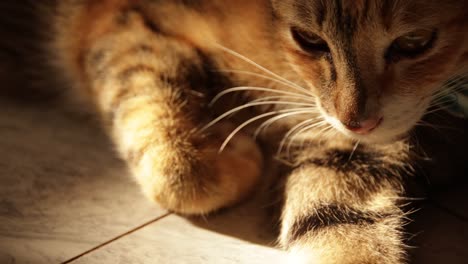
[{"xmin": 280, "ymin": 143, "xmax": 407, "ymax": 264}]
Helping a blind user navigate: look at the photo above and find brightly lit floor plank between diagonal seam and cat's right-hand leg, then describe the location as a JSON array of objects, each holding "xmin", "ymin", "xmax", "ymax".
[{"xmin": 73, "ymin": 157, "xmax": 287, "ymax": 264}]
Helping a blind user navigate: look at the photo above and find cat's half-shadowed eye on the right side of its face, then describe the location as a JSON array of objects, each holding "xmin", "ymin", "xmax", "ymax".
[{"xmin": 392, "ymin": 29, "xmax": 436, "ymax": 57}]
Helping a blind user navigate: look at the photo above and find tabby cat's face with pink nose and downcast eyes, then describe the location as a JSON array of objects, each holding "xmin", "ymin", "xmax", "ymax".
[{"xmin": 273, "ymin": 0, "xmax": 468, "ymax": 142}]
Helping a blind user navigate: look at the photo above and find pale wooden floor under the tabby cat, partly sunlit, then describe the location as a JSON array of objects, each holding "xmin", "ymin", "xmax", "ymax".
[{"xmin": 0, "ymin": 98, "xmax": 468, "ymax": 264}]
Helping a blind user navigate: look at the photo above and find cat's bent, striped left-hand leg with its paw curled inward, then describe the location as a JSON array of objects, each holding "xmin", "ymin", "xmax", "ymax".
[{"xmin": 75, "ymin": 12, "xmax": 262, "ymax": 214}]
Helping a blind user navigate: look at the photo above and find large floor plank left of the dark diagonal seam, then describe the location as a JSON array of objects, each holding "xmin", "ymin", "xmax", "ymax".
[{"xmin": 0, "ymin": 102, "xmax": 165, "ymax": 264}]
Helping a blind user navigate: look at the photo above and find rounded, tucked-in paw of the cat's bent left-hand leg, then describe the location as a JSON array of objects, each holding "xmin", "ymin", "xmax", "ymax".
[{"xmin": 133, "ymin": 123, "xmax": 262, "ymax": 214}]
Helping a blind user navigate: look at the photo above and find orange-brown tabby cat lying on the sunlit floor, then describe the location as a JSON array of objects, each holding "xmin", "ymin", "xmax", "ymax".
[{"xmin": 3, "ymin": 0, "xmax": 468, "ymax": 264}]
